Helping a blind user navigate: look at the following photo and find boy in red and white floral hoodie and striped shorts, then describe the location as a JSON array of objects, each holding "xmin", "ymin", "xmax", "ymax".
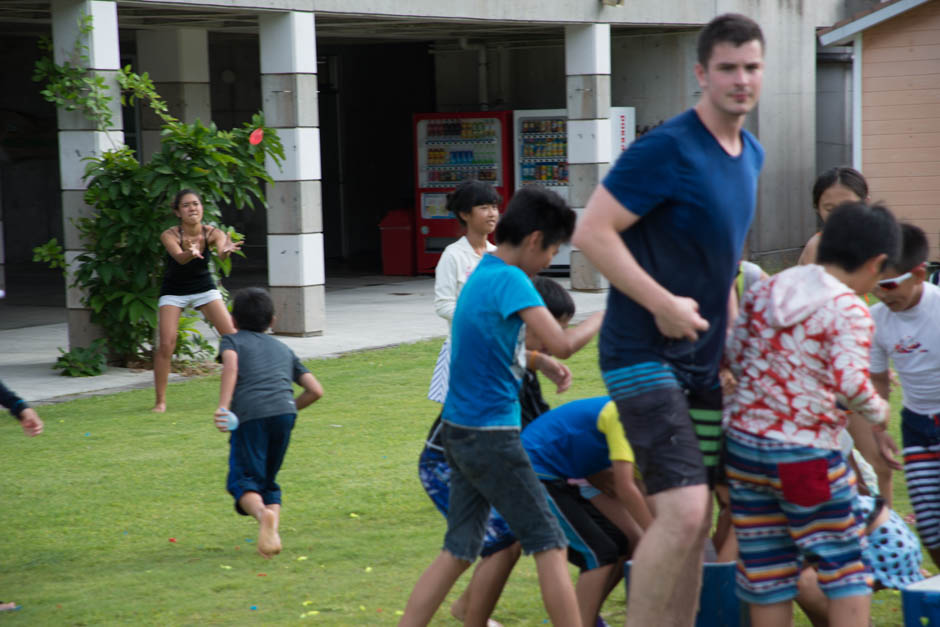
[{"xmin": 724, "ymin": 203, "xmax": 900, "ymax": 625}]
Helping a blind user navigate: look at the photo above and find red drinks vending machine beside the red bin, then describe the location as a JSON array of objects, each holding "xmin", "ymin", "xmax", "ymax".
[{"xmin": 414, "ymin": 111, "xmax": 513, "ymax": 274}]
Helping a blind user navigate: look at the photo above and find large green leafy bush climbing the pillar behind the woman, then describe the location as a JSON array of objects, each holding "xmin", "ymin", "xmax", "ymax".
[{"xmin": 33, "ymin": 18, "xmax": 284, "ymax": 365}]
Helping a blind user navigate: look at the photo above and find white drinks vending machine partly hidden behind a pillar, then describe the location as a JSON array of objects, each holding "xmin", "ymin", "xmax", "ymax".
[{"xmin": 512, "ymin": 107, "xmax": 636, "ymax": 270}]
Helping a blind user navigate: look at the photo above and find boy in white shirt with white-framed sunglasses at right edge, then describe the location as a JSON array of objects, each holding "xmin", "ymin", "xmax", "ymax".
[{"xmin": 871, "ymin": 224, "xmax": 940, "ymax": 566}]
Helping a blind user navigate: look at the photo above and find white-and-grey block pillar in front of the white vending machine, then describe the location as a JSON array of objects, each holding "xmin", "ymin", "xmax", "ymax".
[{"xmin": 565, "ymin": 24, "xmax": 611, "ymax": 291}]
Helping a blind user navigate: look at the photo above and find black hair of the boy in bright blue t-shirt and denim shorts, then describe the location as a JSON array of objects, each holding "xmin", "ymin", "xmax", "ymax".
[{"xmin": 495, "ymin": 185, "xmax": 577, "ymax": 250}]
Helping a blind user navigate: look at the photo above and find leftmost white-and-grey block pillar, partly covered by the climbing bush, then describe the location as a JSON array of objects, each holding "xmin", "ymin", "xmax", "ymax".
[{"xmin": 52, "ymin": 0, "xmax": 124, "ymax": 348}]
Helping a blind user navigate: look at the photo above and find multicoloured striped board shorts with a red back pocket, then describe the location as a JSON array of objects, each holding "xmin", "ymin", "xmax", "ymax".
[{"xmin": 725, "ymin": 429, "xmax": 873, "ymax": 605}]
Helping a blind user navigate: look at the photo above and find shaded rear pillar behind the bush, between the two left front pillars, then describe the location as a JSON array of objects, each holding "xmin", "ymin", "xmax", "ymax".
[{"xmin": 137, "ymin": 28, "xmax": 212, "ymax": 161}]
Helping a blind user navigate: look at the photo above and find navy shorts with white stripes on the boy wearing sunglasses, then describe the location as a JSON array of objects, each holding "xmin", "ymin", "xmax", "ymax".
[{"xmin": 901, "ymin": 408, "xmax": 940, "ymax": 549}]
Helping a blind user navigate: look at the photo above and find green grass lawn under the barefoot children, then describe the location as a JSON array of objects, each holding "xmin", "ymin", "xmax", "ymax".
[{"xmin": 0, "ymin": 341, "xmax": 932, "ymax": 625}]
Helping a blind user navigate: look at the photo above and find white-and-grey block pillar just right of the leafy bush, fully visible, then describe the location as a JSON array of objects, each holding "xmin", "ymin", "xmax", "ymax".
[{"xmin": 258, "ymin": 11, "xmax": 326, "ymax": 336}]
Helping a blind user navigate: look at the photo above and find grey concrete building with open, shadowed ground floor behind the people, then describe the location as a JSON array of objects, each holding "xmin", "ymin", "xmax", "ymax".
[{"xmin": 0, "ymin": 0, "xmax": 877, "ymax": 345}]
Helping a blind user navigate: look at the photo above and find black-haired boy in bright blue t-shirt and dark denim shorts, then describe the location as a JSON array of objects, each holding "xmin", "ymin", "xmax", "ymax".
[{"xmin": 399, "ymin": 187, "xmax": 600, "ymax": 626}]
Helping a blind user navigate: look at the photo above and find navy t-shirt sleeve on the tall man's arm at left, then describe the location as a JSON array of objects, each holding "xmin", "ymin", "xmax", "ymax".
[{"xmin": 603, "ymin": 131, "xmax": 679, "ymax": 216}]
